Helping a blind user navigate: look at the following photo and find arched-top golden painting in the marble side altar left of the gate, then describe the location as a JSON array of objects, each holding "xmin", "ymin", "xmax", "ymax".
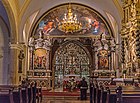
[{"xmin": 34, "ymin": 48, "xmax": 47, "ymax": 69}]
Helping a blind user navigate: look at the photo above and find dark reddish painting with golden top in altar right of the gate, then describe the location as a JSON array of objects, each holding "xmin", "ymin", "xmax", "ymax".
[{"xmin": 98, "ymin": 49, "xmax": 109, "ymax": 70}]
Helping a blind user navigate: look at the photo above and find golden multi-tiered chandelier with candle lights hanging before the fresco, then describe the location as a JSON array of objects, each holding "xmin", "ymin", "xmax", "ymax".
[{"xmin": 58, "ymin": 4, "xmax": 82, "ymax": 33}]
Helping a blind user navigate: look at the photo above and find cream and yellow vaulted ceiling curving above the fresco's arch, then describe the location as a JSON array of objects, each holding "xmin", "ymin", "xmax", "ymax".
[{"xmin": 2, "ymin": 0, "xmax": 123, "ymax": 42}]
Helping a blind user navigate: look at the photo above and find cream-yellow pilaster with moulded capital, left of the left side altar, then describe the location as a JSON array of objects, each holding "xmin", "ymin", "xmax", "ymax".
[{"xmin": 9, "ymin": 43, "xmax": 26, "ymax": 85}]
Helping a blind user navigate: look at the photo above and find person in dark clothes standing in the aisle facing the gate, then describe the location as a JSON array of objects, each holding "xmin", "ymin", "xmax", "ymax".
[{"xmin": 79, "ymin": 77, "xmax": 88, "ymax": 100}]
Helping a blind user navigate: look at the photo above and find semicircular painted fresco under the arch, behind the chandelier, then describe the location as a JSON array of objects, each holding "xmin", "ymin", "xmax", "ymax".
[{"xmin": 33, "ymin": 4, "xmax": 110, "ymax": 35}]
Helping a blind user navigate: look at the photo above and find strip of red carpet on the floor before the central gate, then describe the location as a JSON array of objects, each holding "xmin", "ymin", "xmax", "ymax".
[{"xmin": 42, "ymin": 90, "xmax": 80, "ymax": 96}]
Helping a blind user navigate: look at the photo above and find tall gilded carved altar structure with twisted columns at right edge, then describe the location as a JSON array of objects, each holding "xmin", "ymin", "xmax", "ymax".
[{"xmin": 121, "ymin": 0, "xmax": 140, "ymax": 76}]
